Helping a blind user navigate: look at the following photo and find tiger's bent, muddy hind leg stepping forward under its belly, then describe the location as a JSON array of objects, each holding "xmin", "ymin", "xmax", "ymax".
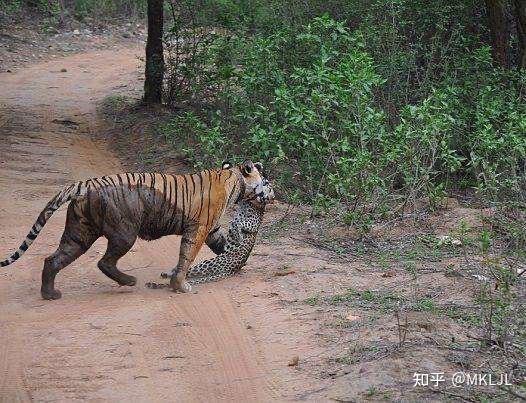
[{"xmin": 97, "ymin": 235, "xmax": 137, "ymax": 286}]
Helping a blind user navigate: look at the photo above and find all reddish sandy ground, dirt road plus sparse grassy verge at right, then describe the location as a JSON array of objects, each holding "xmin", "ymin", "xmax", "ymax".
[{"xmin": 0, "ymin": 43, "xmax": 526, "ymax": 402}]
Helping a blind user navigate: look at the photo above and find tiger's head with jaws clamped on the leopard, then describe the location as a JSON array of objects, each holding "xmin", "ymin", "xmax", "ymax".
[{"xmin": 222, "ymin": 160, "xmax": 275, "ymax": 203}]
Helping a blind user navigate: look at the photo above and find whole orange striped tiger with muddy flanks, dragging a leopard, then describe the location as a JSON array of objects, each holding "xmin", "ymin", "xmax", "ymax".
[{"xmin": 0, "ymin": 160, "xmax": 270, "ymax": 300}]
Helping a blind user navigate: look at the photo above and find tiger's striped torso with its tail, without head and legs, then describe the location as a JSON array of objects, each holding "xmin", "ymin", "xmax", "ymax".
[{"xmin": 0, "ymin": 171, "xmax": 238, "ymax": 266}]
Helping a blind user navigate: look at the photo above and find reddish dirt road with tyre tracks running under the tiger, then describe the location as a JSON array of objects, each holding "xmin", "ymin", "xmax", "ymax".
[{"xmin": 0, "ymin": 48, "xmax": 280, "ymax": 402}]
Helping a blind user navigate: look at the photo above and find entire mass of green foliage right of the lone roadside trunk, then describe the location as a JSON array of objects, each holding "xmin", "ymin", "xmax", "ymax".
[{"xmin": 162, "ymin": 0, "xmax": 526, "ymax": 233}]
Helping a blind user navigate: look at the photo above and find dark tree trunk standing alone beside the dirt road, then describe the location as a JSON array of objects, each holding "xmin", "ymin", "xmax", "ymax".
[{"xmin": 144, "ymin": 0, "xmax": 164, "ymax": 105}]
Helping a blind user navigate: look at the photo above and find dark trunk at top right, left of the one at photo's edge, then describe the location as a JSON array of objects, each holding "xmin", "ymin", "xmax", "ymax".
[{"xmin": 486, "ymin": 0, "xmax": 510, "ymax": 68}]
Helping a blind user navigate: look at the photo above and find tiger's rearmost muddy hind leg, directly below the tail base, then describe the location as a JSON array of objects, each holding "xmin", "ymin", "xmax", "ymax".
[{"xmin": 40, "ymin": 202, "xmax": 99, "ymax": 300}]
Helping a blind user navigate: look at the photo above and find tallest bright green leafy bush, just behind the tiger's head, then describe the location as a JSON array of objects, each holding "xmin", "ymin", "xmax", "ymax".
[{"xmin": 239, "ymin": 17, "xmax": 387, "ymax": 210}]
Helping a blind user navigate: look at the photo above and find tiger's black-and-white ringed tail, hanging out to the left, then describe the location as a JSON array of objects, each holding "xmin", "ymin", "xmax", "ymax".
[{"xmin": 0, "ymin": 182, "xmax": 86, "ymax": 267}]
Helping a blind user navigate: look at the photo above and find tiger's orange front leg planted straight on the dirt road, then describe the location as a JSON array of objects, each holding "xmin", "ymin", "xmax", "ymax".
[{"xmin": 170, "ymin": 226, "xmax": 208, "ymax": 292}]
